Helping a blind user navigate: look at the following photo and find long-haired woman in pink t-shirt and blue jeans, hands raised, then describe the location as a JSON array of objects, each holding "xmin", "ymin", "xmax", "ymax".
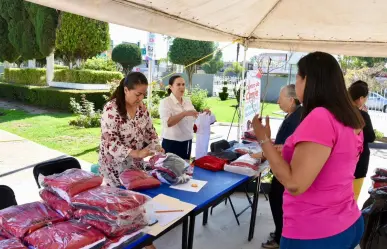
[{"xmin": 253, "ymin": 52, "xmax": 364, "ymax": 249}]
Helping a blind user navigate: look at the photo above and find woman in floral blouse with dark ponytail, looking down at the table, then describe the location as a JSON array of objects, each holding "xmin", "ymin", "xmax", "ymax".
[{"xmin": 99, "ymin": 72, "xmax": 162, "ymax": 186}]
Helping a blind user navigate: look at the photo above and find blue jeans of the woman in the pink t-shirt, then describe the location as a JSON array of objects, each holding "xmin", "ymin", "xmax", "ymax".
[{"xmin": 280, "ymin": 216, "xmax": 364, "ymax": 249}]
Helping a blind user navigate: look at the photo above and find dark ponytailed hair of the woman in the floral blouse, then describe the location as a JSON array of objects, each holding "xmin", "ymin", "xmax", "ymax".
[{"xmin": 110, "ymin": 72, "xmax": 148, "ymax": 118}]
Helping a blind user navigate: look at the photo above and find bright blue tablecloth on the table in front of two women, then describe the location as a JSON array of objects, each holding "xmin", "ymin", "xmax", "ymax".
[{"xmin": 141, "ymin": 167, "xmax": 250, "ymax": 209}]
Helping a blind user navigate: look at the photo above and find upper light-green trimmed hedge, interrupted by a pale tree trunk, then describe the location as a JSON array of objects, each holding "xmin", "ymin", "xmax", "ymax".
[{"xmin": 4, "ymin": 68, "xmax": 124, "ymax": 86}]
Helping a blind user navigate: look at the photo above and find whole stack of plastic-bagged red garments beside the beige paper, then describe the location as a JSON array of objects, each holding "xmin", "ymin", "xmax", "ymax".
[{"xmin": 71, "ymin": 186, "xmax": 150, "ymax": 238}]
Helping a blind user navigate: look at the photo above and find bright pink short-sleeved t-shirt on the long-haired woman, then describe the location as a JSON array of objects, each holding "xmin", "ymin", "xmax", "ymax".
[{"xmin": 282, "ymin": 107, "xmax": 363, "ymax": 239}]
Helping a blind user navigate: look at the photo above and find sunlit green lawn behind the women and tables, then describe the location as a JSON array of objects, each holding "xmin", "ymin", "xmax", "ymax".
[{"xmin": 0, "ymin": 98, "xmax": 279, "ymax": 163}]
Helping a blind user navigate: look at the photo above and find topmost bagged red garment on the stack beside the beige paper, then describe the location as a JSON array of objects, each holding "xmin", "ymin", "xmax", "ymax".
[{"xmin": 71, "ymin": 186, "xmax": 151, "ymax": 215}]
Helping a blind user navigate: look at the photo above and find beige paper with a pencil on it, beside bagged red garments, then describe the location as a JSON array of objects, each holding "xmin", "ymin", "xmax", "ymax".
[{"xmin": 147, "ymin": 194, "xmax": 196, "ymax": 236}]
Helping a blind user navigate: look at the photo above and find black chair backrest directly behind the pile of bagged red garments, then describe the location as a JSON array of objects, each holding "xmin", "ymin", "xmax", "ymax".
[{"xmin": 33, "ymin": 157, "xmax": 81, "ymax": 188}]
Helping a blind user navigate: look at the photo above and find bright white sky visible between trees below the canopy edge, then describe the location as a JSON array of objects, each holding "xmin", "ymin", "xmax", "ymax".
[{"xmin": 110, "ymin": 24, "xmax": 283, "ymax": 62}]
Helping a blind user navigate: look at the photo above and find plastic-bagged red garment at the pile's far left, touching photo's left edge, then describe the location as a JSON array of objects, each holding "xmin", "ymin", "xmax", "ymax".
[{"xmin": 0, "ymin": 202, "xmax": 64, "ymax": 238}]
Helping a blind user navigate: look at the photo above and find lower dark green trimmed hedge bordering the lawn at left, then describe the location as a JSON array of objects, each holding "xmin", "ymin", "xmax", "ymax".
[{"xmin": 0, "ymin": 83, "xmax": 109, "ymax": 111}]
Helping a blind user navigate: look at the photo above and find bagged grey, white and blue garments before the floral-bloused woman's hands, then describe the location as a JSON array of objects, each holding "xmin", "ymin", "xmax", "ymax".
[{"xmin": 149, "ymin": 153, "xmax": 191, "ymax": 184}]
